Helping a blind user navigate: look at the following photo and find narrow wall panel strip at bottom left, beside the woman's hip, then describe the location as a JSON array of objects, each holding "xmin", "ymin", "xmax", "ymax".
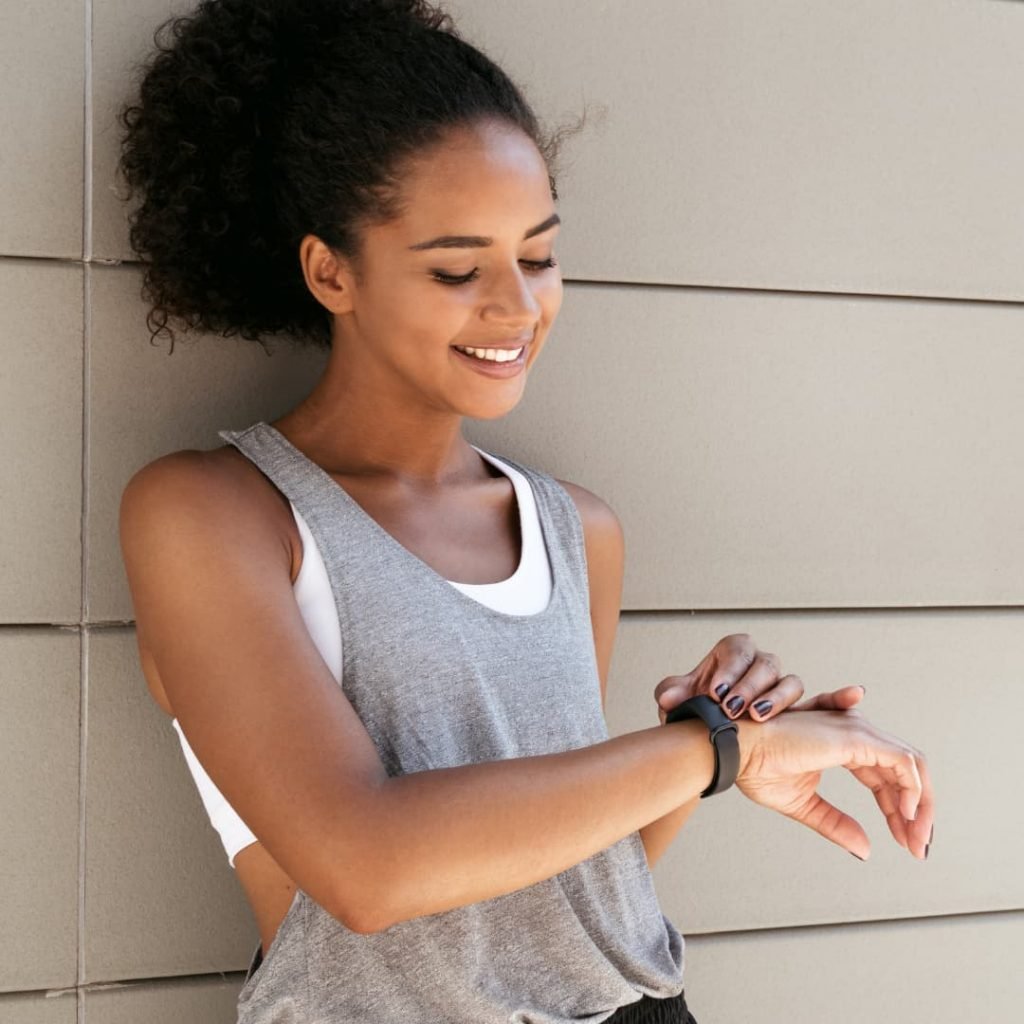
[{"xmin": 85, "ymin": 975, "xmax": 245, "ymax": 1024}]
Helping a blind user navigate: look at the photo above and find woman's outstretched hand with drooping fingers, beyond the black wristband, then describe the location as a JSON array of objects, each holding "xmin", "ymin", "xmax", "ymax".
[{"xmin": 735, "ymin": 709, "xmax": 935, "ymax": 860}]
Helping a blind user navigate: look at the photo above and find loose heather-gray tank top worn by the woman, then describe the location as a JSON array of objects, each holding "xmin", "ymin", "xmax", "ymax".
[{"xmin": 224, "ymin": 421, "xmax": 684, "ymax": 1024}]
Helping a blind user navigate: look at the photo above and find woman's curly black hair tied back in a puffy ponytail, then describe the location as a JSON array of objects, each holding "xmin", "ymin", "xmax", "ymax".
[{"xmin": 118, "ymin": 0, "xmax": 586, "ymax": 350}]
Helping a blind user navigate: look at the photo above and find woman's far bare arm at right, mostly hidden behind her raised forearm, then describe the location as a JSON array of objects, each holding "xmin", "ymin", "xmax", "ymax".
[{"xmin": 558, "ymin": 480, "xmax": 700, "ymax": 867}]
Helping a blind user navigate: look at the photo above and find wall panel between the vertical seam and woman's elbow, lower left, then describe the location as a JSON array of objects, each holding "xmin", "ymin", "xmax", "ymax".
[{"xmin": 84, "ymin": 628, "xmax": 259, "ymax": 983}]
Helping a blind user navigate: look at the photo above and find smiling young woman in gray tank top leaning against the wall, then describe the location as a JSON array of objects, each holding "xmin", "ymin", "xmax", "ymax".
[{"xmin": 121, "ymin": 0, "xmax": 933, "ymax": 1024}]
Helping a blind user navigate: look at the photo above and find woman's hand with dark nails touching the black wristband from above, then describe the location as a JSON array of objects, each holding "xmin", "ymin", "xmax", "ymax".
[{"xmin": 654, "ymin": 633, "xmax": 866, "ymax": 725}]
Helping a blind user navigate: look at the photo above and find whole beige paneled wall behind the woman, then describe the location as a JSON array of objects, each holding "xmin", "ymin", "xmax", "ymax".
[{"xmin": 0, "ymin": 0, "xmax": 1024, "ymax": 1024}]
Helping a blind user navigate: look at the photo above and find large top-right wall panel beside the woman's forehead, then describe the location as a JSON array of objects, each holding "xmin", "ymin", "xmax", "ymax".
[{"xmin": 446, "ymin": 0, "xmax": 1024, "ymax": 301}]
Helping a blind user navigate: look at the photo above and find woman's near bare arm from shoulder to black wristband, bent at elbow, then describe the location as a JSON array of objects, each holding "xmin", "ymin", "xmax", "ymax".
[{"xmin": 120, "ymin": 453, "xmax": 741, "ymax": 933}]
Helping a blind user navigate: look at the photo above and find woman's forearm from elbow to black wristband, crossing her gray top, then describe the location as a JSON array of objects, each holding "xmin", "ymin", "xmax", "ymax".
[{"xmin": 356, "ymin": 721, "xmax": 715, "ymax": 931}]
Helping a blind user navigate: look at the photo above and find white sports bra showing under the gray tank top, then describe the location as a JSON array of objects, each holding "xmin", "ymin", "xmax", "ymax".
[{"xmin": 171, "ymin": 444, "xmax": 551, "ymax": 867}]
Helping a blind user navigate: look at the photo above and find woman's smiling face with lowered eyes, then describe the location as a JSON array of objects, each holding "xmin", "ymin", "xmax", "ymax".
[{"xmin": 303, "ymin": 118, "xmax": 562, "ymax": 419}]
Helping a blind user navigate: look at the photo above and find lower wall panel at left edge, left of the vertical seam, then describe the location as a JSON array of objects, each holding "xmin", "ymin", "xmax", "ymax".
[{"xmin": 0, "ymin": 628, "xmax": 81, "ymax": 991}]
